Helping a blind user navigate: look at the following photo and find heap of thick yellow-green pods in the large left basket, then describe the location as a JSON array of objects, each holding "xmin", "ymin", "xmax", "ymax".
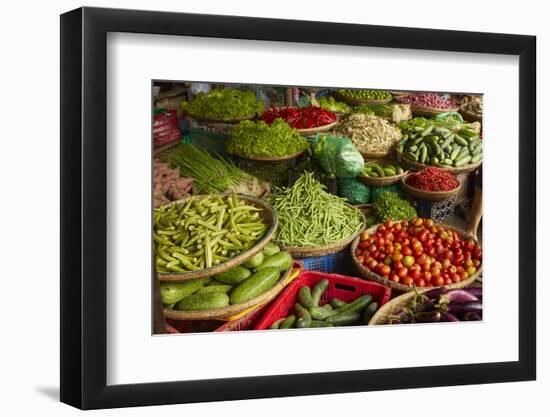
[{"xmin": 153, "ymin": 194, "xmax": 267, "ymax": 272}]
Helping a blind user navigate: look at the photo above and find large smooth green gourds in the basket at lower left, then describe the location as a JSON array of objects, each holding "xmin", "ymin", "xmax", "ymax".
[{"xmin": 160, "ymin": 243, "xmax": 293, "ymax": 311}]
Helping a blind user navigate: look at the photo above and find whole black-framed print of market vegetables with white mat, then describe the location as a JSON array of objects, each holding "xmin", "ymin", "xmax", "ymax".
[{"xmin": 61, "ymin": 8, "xmax": 536, "ymax": 409}]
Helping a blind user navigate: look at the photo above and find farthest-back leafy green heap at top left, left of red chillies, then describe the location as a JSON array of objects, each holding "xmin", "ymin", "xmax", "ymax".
[{"xmin": 180, "ymin": 88, "xmax": 264, "ymax": 121}]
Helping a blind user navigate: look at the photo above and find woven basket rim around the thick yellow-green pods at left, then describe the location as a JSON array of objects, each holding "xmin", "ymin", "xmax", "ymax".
[{"xmin": 157, "ymin": 194, "xmax": 278, "ymax": 281}]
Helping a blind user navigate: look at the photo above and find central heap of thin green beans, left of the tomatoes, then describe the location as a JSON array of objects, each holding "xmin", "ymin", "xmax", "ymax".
[{"xmin": 268, "ymin": 172, "xmax": 362, "ymax": 247}]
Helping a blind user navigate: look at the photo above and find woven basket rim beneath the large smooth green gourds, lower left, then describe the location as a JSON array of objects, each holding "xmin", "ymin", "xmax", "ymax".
[{"xmin": 164, "ymin": 265, "xmax": 293, "ymax": 320}]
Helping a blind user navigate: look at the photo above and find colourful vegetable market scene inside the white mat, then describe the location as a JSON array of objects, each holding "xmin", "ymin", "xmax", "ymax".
[{"xmin": 152, "ymin": 82, "xmax": 483, "ymax": 333}]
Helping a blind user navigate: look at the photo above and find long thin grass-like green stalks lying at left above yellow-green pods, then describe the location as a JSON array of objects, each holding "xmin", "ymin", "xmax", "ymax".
[{"xmin": 159, "ymin": 144, "xmax": 254, "ymax": 194}]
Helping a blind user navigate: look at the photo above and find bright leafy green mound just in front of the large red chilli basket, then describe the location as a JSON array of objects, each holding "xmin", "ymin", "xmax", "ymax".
[{"xmin": 227, "ymin": 119, "xmax": 309, "ymax": 158}]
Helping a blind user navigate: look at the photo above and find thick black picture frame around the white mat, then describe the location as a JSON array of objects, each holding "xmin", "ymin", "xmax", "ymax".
[{"xmin": 60, "ymin": 7, "xmax": 536, "ymax": 409}]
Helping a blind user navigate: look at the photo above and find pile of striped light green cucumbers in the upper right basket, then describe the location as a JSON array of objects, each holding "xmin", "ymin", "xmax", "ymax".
[{"xmin": 397, "ymin": 125, "xmax": 483, "ymax": 168}]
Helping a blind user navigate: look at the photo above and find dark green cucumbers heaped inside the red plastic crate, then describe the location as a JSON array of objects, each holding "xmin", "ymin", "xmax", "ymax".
[{"xmin": 270, "ymin": 279, "xmax": 378, "ymax": 329}]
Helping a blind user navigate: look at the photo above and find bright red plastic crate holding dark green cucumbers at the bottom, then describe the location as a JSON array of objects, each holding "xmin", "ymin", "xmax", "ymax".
[{"xmin": 256, "ymin": 271, "xmax": 391, "ymax": 330}]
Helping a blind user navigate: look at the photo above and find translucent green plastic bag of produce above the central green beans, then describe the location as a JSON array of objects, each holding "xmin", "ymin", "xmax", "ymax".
[{"xmin": 313, "ymin": 134, "xmax": 365, "ymax": 177}]
